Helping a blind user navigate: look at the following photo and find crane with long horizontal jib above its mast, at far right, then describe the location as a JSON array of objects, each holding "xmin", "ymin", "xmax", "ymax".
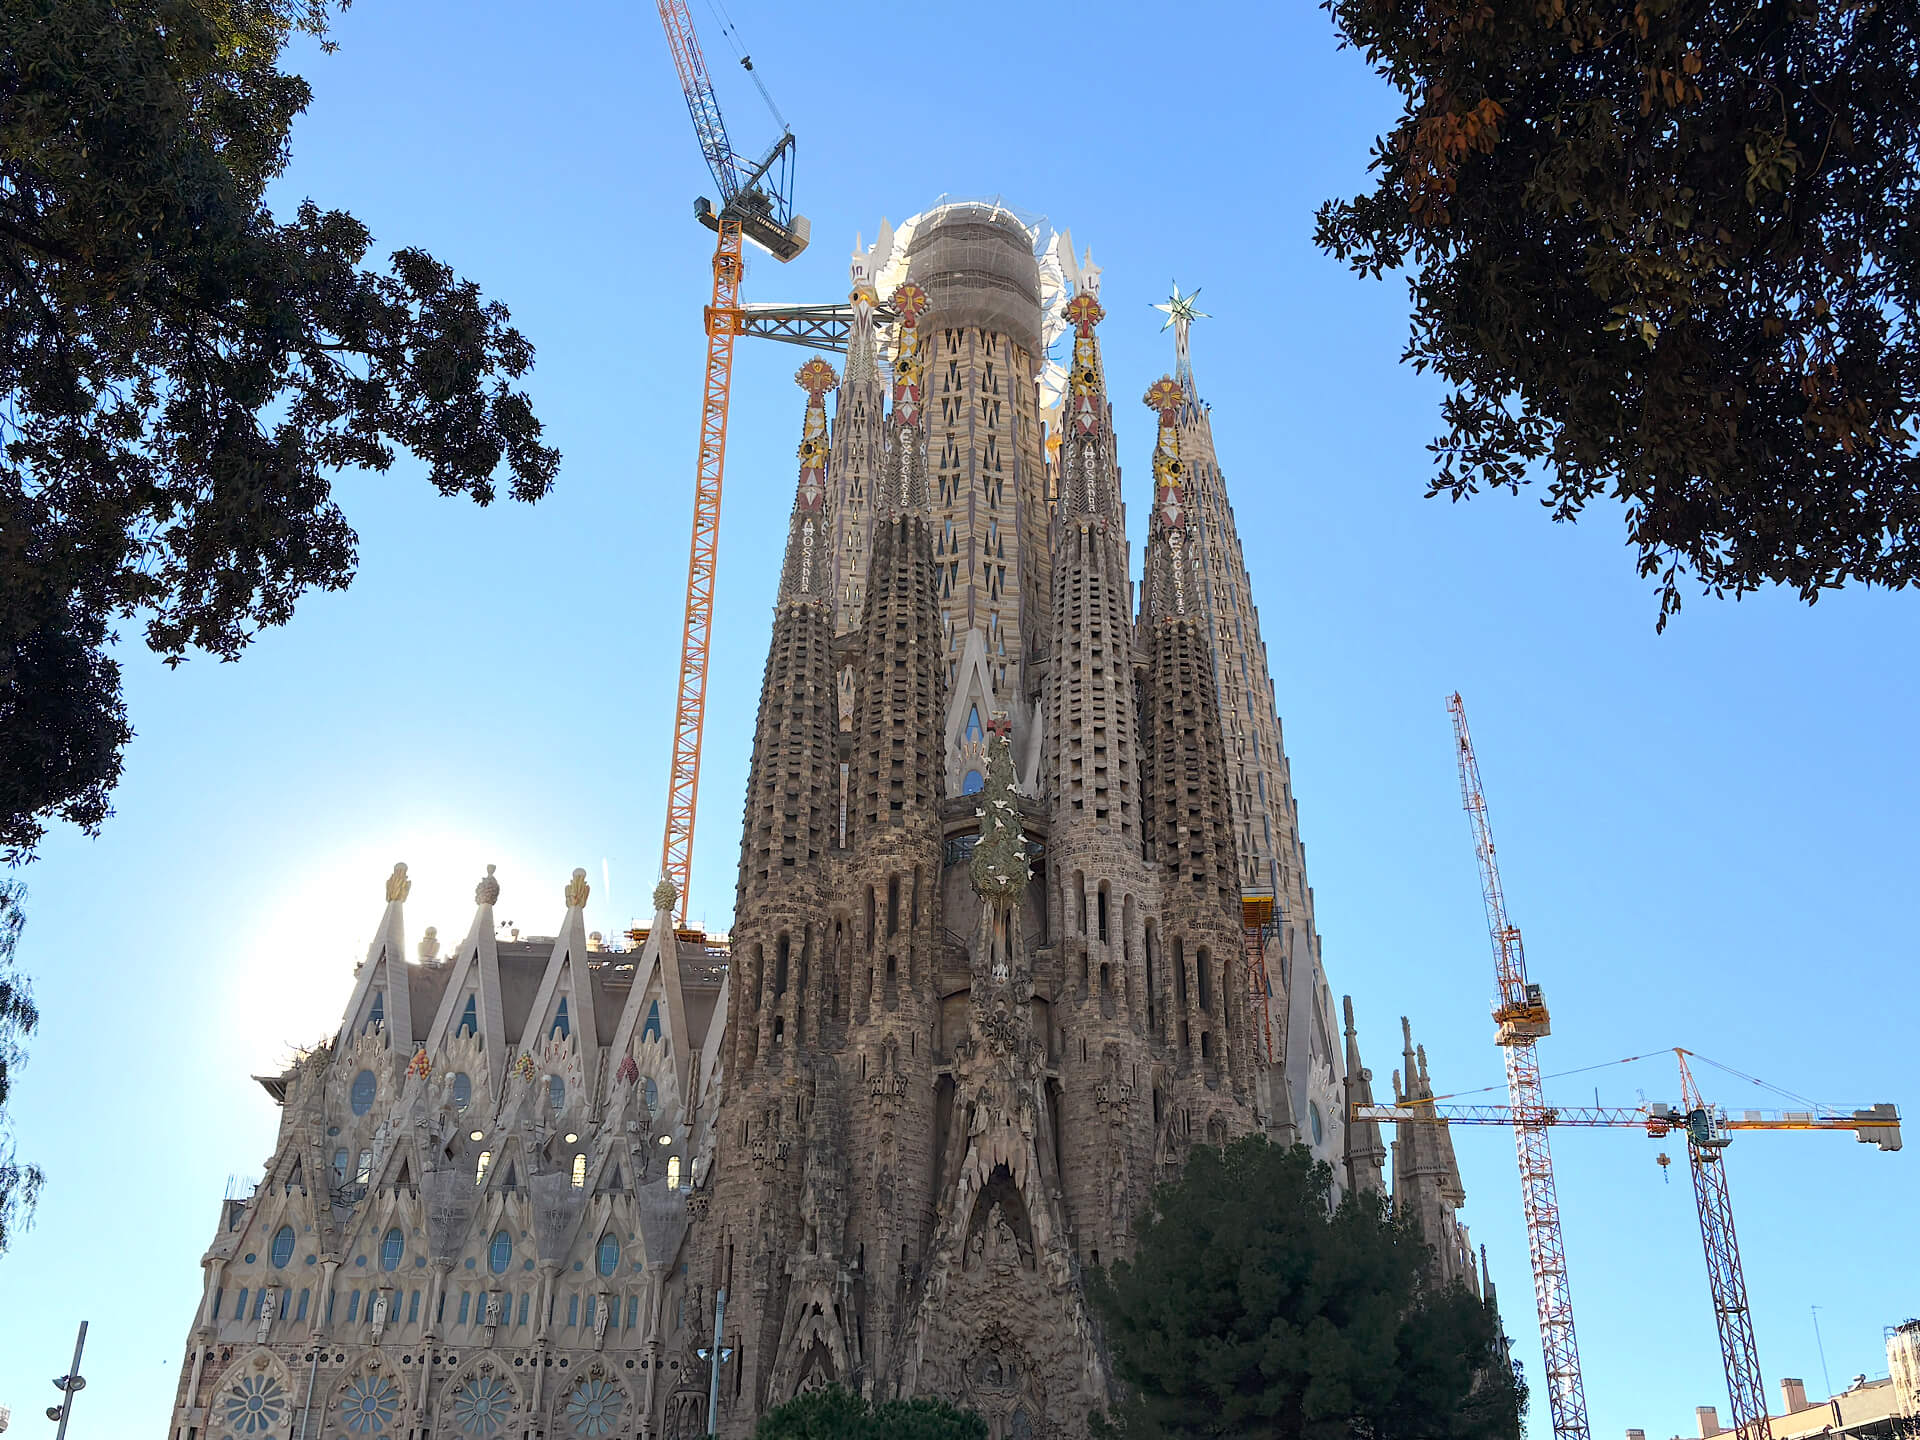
[{"xmin": 1352, "ymin": 1050, "xmax": 1901, "ymax": 1440}]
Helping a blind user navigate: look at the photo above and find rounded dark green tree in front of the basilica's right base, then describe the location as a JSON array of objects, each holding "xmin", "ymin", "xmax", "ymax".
[{"xmin": 1091, "ymin": 1135, "xmax": 1526, "ymax": 1440}]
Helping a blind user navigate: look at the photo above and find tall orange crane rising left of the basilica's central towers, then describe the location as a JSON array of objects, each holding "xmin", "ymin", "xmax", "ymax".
[{"xmin": 659, "ymin": 0, "xmax": 810, "ymax": 925}]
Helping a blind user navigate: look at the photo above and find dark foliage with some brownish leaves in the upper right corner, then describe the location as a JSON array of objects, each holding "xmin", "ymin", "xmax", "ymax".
[{"xmin": 1317, "ymin": 0, "xmax": 1920, "ymax": 624}]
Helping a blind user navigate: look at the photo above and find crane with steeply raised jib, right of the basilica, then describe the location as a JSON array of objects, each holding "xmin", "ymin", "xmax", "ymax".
[{"xmin": 1448, "ymin": 693, "xmax": 1590, "ymax": 1440}]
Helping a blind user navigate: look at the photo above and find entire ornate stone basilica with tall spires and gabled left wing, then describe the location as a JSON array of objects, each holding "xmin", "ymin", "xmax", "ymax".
[{"xmin": 171, "ymin": 204, "xmax": 1478, "ymax": 1440}]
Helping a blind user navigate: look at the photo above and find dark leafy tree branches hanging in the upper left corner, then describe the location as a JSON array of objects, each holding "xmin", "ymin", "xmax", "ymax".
[{"xmin": 0, "ymin": 0, "xmax": 559, "ymax": 860}]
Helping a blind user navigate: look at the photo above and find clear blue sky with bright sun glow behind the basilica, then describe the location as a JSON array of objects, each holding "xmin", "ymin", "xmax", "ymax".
[{"xmin": 0, "ymin": 0, "xmax": 1920, "ymax": 1436}]
